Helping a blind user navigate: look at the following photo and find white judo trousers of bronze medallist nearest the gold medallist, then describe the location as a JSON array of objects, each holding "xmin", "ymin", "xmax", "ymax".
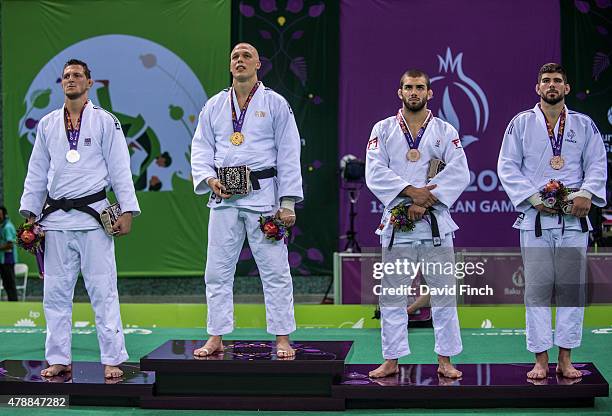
[{"xmin": 380, "ymin": 234, "xmax": 463, "ymax": 360}]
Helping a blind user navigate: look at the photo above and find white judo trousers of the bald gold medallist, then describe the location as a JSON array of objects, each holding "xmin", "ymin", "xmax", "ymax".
[{"xmin": 204, "ymin": 207, "xmax": 296, "ymax": 335}]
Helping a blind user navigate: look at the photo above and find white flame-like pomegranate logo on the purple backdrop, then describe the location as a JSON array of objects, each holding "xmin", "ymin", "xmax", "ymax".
[{"xmin": 431, "ymin": 48, "xmax": 489, "ymax": 147}]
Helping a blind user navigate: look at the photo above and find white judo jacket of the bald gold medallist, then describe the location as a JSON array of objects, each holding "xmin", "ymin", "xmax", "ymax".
[{"xmin": 191, "ymin": 83, "xmax": 303, "ymax": 212}]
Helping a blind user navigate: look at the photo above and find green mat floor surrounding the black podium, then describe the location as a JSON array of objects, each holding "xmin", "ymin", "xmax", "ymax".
[{"xmin": 0, "ymin": 328, "xmax": 612, "ymax": 416}]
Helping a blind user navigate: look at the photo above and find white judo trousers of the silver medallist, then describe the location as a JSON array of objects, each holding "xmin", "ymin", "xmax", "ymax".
[{"xmin": 43, "ymin": 228, "xmax": 128, "ymax": 365}]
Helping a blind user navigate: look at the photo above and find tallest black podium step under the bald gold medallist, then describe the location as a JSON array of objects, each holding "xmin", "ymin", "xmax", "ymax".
[{"xmin": 140, "ymin": 340, "xmax": 353, "ymax": 410}]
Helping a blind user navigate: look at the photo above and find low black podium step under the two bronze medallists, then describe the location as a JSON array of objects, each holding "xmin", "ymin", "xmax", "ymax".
[{"xmin": 333, "ymin": 363, "xmax": 609, "ymax": 409}]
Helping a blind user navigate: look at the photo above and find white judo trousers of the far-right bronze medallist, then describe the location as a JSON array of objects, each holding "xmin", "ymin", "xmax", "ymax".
[{"xmin": 521, "ymin": 228, "xmax": 588, "ymax": 353}]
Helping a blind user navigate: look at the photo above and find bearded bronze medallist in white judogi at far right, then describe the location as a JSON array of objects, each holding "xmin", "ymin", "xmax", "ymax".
[{"xmin": 497, "ymin": 63, "xmax": 607, "ymax": 379}]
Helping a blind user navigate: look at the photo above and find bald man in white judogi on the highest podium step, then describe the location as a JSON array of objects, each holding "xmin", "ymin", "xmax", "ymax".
[{"xmin": 191, "ymin": 43, "xmax": 303, "ymax": 358}]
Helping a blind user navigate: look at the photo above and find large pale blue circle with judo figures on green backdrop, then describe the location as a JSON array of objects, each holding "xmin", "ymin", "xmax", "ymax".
[{"xmin": 19, "ymin": 35, "xmax": 207, "ymax": 191}]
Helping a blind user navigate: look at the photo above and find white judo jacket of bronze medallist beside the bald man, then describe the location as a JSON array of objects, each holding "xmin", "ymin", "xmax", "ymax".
[{"xmin": 366, "ymin": 112, "xmax": 470, "ymax": 241}]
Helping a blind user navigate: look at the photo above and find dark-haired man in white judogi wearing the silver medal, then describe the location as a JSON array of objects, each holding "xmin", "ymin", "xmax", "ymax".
[{"xmin": 19, "ymin": 59, "xmax": 140, "ymax": 378}]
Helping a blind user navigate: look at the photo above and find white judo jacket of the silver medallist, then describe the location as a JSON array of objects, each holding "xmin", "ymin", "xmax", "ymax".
[{"xmin": 19, "ymin": 101, "xmax": 140, "ymax": 226}]
